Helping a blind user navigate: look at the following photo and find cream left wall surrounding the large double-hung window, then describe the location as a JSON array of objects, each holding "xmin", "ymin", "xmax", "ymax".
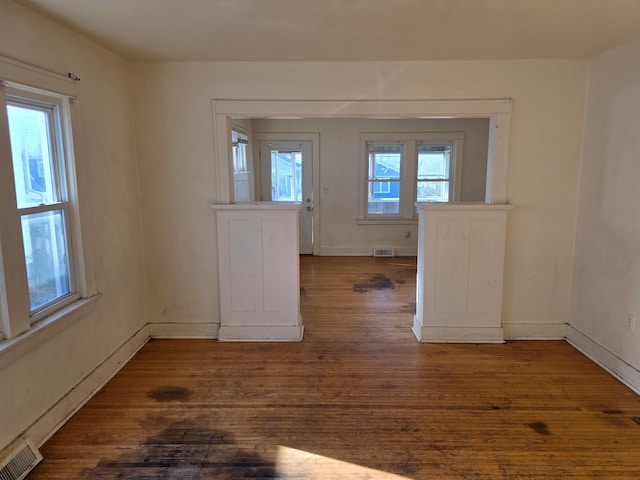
[{"xmin": 0, "ymin": 0, "xmax": 146, "ymax": 449}]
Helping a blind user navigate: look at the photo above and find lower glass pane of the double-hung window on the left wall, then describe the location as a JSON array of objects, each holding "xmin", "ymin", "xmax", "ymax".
[{"xmin": 22, "ymin": 210, "xmax": 71, "ymax": 312}]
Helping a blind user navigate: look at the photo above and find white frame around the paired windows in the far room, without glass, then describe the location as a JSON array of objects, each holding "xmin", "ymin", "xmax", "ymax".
[{"xmin": 357, "ymin": 132, "xmax": 464, "ymax": 224}]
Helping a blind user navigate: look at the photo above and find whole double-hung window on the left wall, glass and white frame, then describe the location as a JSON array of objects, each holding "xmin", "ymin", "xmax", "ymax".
[{"xmin": 0, "ymin": 78, "xmax": 84, "ymax": 338}]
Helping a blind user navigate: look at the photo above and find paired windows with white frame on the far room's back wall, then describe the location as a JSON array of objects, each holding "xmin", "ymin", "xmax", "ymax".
[{"xmin": 359, "ymin": 132, "xmax": 464, "ymax": 223}]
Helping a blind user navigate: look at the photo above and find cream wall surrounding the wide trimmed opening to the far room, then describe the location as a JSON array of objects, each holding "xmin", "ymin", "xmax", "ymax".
[{"xmin": 133, "ymin": 60, "xmax": 588, "ymax": 338}]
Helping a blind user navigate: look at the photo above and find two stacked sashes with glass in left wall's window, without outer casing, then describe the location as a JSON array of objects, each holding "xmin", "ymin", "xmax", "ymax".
[{"xmin": 5, "ymin": 88, "xmax": 79, "ymax": 322}]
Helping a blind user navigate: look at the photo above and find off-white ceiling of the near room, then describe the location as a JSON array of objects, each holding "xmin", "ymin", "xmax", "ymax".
[{"xmin": 16, "ymin": 0, "xmax": 640, "ymax": 61}]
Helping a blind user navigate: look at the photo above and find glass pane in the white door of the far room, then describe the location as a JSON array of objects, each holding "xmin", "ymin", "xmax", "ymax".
[{"xmin": 271, "ymin": 150, "xmax": 302, "ymax": 202}]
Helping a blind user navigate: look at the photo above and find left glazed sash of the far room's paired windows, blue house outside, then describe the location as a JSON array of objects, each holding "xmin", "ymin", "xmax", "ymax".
[{"xmin": 367, "ymin": 142, "xmax": 402, "ymax": 215}]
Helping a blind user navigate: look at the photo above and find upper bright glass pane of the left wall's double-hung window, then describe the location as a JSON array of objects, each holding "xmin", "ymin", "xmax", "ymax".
[{"xmin": 7, "ymin": 105, "xmax": 58, "ymax": 208}]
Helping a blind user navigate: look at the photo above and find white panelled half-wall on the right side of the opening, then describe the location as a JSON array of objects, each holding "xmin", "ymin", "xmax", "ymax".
[{"xmin": 413, "ymin": 204, "xmax": 510, "ymax": 343}]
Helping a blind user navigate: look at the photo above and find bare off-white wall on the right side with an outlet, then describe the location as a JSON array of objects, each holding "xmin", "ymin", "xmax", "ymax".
[{"xmin": 569, "ymin": 37, "xmax": 640, "ymax": 390}]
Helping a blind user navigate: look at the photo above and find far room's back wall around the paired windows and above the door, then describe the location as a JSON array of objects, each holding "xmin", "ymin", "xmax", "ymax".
[{"xmin": 253, "ymin": 118, "xmax": 489, "ymax": 255}]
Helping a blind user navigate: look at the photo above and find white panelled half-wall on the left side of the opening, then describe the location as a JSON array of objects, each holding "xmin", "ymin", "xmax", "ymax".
[{"xmin": 212, "ymin": 202, "xmax": 303, "ymax": 341}]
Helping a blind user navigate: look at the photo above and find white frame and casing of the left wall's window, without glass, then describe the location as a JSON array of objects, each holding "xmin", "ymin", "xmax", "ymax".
[{"xmin": 0, "ymin": 57, "xmax": 97, "ymax": 342}]
